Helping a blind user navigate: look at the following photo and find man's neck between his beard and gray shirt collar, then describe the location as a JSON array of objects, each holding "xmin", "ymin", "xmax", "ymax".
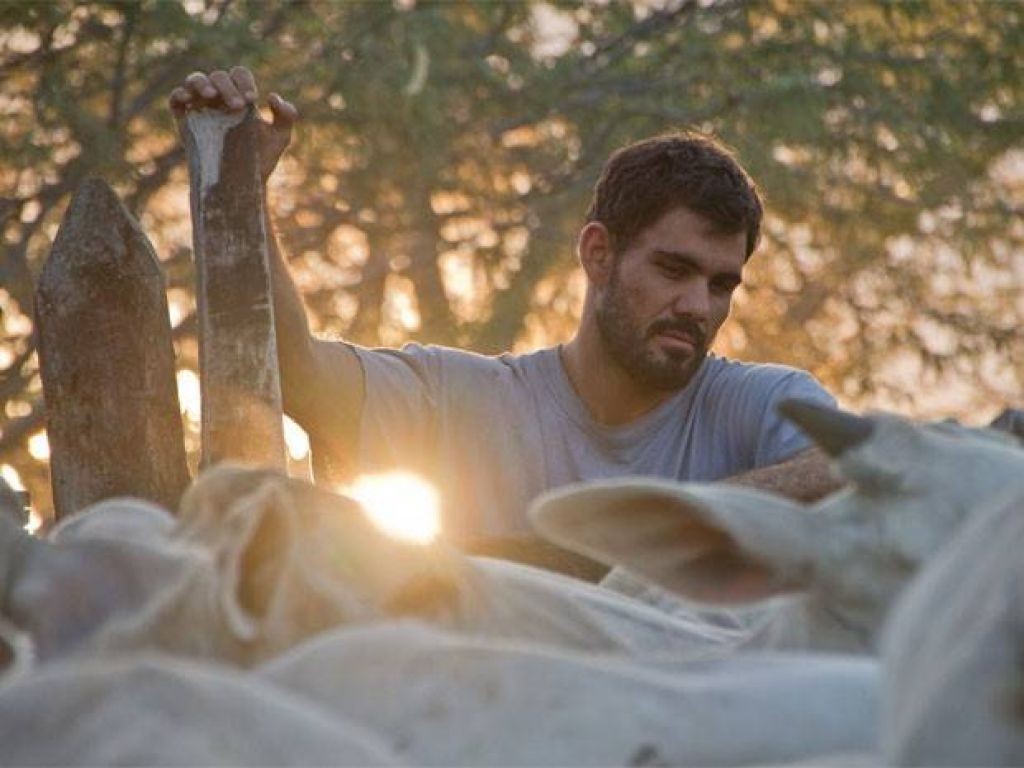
[{"xmin": 560, "ymin": 332, "xmax": 679, "ymax": 427}]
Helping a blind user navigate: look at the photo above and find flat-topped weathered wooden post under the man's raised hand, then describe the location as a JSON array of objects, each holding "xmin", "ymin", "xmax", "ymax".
[{"xmin": 184, "ymin": 108, "xmax": 286, "ymax": 469}]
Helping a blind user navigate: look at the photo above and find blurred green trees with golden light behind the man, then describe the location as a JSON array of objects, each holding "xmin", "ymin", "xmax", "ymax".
[{"xmin": 0, "ymin": 0, "xmax": 1024, "ymax": 524}]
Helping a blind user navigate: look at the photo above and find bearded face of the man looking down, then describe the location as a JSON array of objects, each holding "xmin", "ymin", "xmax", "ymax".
[{"xmin": 596, "ymin": 208, "xmax": 746, "ymax": 390}]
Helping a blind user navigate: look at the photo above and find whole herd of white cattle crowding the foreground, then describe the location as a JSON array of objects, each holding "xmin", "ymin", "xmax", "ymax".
[{"xmin": 0, "ymin": 403, "xmax": 1024, "ymax": 766}]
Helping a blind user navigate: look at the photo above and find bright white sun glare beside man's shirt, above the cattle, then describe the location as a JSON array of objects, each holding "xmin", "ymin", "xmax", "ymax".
[{"xmin": 345, "ymin": 472, "xmax": 440, "ymax": 544}]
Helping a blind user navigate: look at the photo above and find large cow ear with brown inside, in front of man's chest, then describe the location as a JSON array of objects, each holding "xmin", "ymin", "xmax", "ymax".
[{"xmin": 530, "ymin": 479, "xmax": 812, "ymax": 605}]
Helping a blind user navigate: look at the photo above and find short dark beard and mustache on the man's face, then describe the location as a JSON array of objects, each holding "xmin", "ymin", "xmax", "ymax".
[{"xmin": 595, "ymin": 273, "xmax": 709, "ymax": 391}]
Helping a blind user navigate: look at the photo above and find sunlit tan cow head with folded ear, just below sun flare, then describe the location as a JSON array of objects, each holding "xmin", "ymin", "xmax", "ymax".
[{"xmin": 180, "ymin": 466, "xmax": 458, "ymax": 652}]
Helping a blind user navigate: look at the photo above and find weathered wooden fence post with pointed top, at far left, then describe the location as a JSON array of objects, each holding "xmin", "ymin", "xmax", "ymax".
[{"xmin": 36, "ymin": 179, "xmax": 188, "ymax": 517}]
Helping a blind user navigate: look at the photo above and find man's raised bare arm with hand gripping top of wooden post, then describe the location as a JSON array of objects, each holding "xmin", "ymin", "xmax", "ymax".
[{"xmin": 169, "ymin": 67, "xmax": 364, "ymax": 475}]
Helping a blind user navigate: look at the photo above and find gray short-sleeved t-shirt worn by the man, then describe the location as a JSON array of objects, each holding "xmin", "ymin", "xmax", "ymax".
[{"xmin": 352, "ymin": 344, "xmax": 835, "ymax": 536}]
